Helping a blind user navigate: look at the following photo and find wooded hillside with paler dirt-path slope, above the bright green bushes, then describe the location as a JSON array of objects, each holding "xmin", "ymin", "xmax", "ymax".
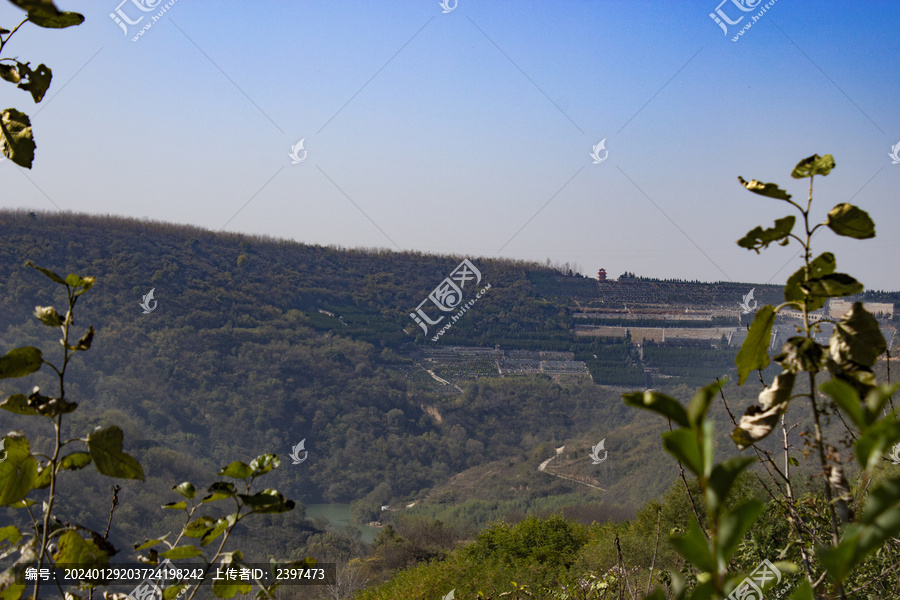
[{"xmin": 0, "ymin": 211, "xmax": 895, "ymax": 596}]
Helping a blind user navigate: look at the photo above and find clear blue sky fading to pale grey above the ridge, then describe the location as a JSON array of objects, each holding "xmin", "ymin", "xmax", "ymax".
[{"xmin": 0, "ymin": 0, "xmax": 900, "ymax": 290}]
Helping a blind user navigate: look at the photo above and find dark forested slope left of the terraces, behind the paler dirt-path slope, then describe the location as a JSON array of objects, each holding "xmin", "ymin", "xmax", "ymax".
[{"xmin": 0, "ymin": 212, "xmax": 704, "ymax": 564}]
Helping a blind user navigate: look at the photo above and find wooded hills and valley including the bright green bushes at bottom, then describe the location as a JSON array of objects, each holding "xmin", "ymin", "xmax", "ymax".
[{"xmin": 0, "ymin": 180, "xmax": 894, "ymax": 598}]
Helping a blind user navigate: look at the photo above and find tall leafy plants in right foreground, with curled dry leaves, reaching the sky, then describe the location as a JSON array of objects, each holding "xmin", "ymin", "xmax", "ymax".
[{"xmin": 625, "ymin": 154, "xmax": 900, "ymax": 600}]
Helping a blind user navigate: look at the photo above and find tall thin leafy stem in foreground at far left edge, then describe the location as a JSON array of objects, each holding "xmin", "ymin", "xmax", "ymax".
[{"xmin": 0, "ymin": 262, "xmax": 144, "ymax": 600}]
